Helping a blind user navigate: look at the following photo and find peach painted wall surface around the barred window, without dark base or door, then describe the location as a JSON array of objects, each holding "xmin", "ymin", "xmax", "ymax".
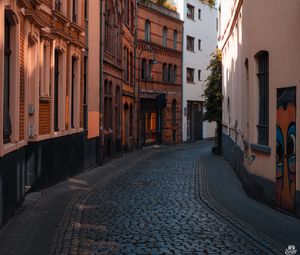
[{"xmin": 219, "ymin": 0, "xmax": 300, "ymax": 198}]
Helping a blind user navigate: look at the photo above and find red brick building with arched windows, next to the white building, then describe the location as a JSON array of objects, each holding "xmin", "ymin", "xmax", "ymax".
[{"xmin": 136, "ymin": 2, "xmax": 183, "ymax": 145}]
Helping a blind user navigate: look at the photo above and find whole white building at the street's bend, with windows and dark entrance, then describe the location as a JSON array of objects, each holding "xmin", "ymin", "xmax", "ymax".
[{"xmin": 174, "ymin": 0, "xmax": 218, "ymax": 141}]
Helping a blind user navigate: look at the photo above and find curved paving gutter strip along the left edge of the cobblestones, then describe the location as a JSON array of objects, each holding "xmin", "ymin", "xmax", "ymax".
[{"xmin": 49, "ymin": 151, "xmax": 158, "ymax": 255}]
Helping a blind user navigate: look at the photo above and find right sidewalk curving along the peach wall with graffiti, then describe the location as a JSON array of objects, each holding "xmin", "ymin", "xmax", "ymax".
[{"xmin": 200, "ymin": 148, "xmax": 300, "ymax": 248}]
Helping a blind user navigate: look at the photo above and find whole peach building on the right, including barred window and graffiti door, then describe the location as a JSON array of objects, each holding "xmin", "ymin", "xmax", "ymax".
[{"xmin": 219, "ymin": 0, "xmax": 300, "ymax": 216}]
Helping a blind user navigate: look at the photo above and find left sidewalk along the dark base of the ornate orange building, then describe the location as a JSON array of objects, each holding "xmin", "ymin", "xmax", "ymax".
[{"xmin": 0, "ymin": 148, "xmax": 159, "ymax": 255}]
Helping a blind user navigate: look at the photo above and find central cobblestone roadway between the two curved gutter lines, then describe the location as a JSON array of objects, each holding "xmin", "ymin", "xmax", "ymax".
[{"xmin": 70, "ymin": 143, "xmax": 282, "ymax": 254}]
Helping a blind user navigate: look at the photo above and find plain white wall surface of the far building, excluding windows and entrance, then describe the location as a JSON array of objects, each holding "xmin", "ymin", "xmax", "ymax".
[{"xmin": 174, "ymin": 0, "xmax": 217, "ymax": 141}]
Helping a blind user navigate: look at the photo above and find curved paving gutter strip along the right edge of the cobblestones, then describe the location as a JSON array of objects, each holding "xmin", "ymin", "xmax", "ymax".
[{"xmin": 195, "ymin": 158, "xmax": 285, "ymax": 254}]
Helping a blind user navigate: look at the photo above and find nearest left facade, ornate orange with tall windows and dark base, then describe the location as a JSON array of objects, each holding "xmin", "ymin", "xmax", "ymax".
[{"xmin": 0, "ymin": 0, "xmax": 85, "ymax": 223}]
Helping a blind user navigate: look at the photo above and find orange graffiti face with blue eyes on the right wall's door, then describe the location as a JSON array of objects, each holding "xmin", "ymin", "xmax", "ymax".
[{"xmin": 276, "ymin": 87, "xmax": 296, "ymax": 211}]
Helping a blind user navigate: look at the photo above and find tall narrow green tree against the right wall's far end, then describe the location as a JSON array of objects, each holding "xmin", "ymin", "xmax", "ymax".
[{"xmin": 203, "ymin": 49, "xmax": 223, "ymax": 152}]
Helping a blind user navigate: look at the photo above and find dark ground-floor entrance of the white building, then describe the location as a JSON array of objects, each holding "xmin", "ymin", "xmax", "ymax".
[{"xmin": 187, "ymin": 101, "xmax": 203, "ymax": 141}]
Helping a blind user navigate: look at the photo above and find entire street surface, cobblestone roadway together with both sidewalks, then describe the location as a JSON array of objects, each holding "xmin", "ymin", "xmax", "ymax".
[{"xmin": 0, "ymin": 142, "xmax": 300, "ymax": 255}]
